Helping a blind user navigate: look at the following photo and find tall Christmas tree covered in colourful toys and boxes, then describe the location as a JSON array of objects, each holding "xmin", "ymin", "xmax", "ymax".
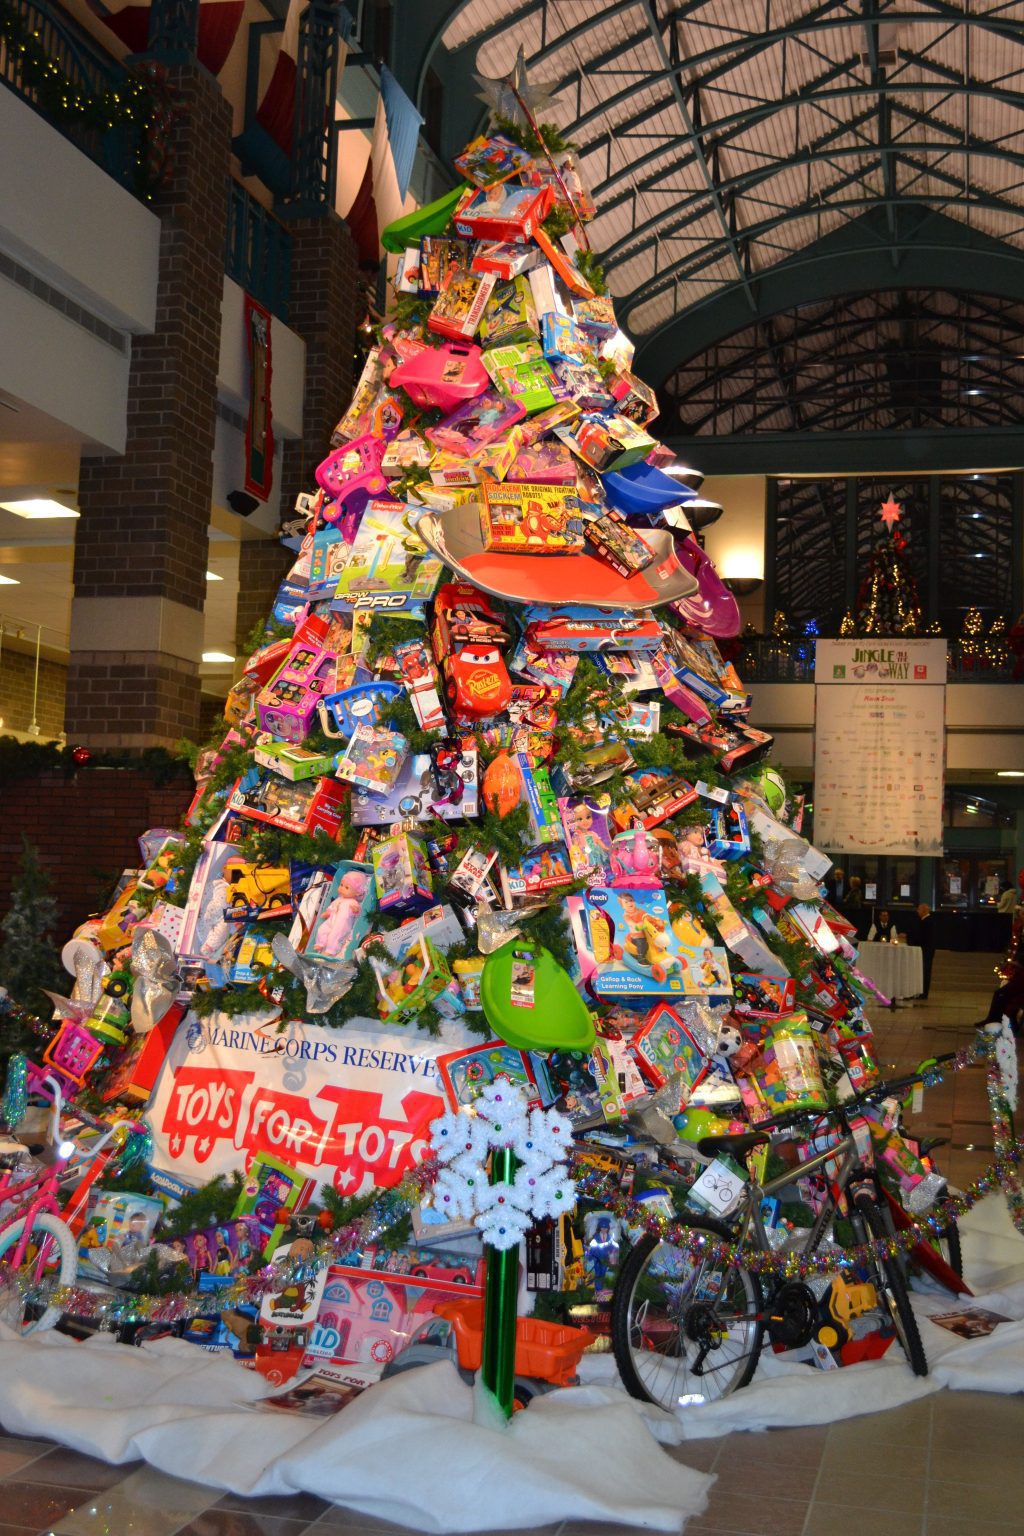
[{"xmin": 0, "ymin": 69, "xmax": 924, "ymax": 1357}]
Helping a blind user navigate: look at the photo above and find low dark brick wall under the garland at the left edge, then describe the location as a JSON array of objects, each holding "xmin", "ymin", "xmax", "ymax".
[{"xmin": 0, "ymin": 768, "xmax": 193, "ymax": 942}]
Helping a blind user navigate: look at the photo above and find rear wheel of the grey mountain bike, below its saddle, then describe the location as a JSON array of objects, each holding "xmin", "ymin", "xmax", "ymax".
[{"xmin": 611, "ymin": 1220, "xmax": 765, "ymax": 1413}]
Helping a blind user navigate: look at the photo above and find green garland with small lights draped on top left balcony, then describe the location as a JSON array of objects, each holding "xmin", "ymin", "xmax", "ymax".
[{"xmin": 0, "ymin": 0, "xmax": 178, "ymax": 203}]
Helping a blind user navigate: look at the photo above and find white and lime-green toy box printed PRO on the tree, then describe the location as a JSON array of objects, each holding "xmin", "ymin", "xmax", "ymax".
[{"xmin": 327, "ymin": 501, "xmax": 442, "ymax": 614}]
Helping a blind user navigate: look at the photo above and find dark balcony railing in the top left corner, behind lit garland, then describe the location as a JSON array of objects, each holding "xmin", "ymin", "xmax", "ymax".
[{"xmin": 0, "ymin": 0, "xmax": 143, "ymax": 195}]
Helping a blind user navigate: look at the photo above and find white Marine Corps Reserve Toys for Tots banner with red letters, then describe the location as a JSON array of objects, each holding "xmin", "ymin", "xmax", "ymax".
[{"xmin": 146, "ymin": 1014, "xmax": 451, "ymax": 1197}]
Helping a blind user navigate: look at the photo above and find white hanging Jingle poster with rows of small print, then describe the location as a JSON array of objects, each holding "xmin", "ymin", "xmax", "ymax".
[{"xmin": 814, "ymin": 639, "xmax": 946, "ymax": 857}]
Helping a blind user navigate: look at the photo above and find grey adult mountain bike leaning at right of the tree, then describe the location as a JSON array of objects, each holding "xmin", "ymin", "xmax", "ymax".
[{"xmin": 611, "ymin": 1055, "xmax": 952, "ymax": 1412}]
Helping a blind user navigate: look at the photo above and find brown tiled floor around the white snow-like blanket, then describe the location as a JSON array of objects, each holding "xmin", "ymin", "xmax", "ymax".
[{"xmin": 0, "ymin": 954, "xmax": 1024, "ymax": 1536}]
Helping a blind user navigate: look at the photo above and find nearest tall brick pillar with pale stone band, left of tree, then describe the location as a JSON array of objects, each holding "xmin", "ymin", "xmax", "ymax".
[{"xmin": 66, "ymin": 63, "xmax": 230, "ymax": 748}]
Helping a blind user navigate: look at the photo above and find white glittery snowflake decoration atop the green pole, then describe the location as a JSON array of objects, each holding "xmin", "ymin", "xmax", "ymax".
[{"xmin": 430, "ymin": 1078, "xmax": 576, "ymax": 1249}]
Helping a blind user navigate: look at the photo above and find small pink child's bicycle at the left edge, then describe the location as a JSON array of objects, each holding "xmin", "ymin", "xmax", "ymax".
[{"xmin": 0, "ymin": 1077, "xmax": 130, "ymax": 1335}]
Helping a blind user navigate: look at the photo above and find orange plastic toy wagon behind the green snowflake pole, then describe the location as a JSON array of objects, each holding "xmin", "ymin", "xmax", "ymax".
[{"xmin": 382, "ymin": 1298, "xmax": 597, "ymax": 1409}]
